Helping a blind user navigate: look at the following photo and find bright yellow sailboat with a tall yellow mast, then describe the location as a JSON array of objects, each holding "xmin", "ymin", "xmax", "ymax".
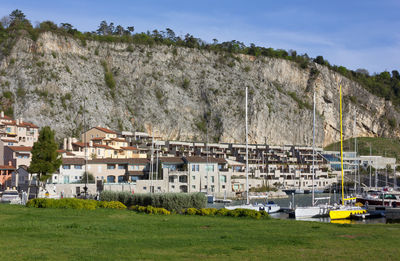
[{"xmin": 329, "ymin": 85, "xmax": 367, "ymax": 220}]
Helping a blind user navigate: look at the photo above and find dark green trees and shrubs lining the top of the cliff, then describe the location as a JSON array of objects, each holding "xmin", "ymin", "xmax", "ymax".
[{"xmin": 0, "ymin": 9, "xmax": 400, "ymax": 105}]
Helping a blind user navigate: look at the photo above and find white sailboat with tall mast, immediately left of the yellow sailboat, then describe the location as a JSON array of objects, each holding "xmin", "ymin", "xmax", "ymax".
[{"xmin": 294, "ymin": 92, "xmax": 331, "ymax": 219}]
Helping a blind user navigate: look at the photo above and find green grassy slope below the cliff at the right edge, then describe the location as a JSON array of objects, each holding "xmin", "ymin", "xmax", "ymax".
[{"xmin": 324, "ymin": 137, "xmax": 400, "ymax": 161}]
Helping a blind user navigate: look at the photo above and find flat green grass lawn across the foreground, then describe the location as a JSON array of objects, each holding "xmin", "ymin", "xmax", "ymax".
[{"xmin": 0, "ymin": 204, "xmax": 400, "ymax": 260}]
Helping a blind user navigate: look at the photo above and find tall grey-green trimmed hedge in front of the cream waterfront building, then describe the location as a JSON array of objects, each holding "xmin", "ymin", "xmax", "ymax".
[{"xmin": 100, "ymin": 191, "xmax": 207, "ymax": 213}]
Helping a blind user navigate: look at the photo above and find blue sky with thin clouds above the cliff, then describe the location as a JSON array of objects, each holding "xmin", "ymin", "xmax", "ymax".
[{"xmin": 0, "ymin": 0, "xmax": 400, "ymax": 73}]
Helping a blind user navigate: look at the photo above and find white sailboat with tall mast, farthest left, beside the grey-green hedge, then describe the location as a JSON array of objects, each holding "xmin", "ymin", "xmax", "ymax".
[{"xmin": 225, "ymin": 87, "xmax": 281, "ymax": 213}]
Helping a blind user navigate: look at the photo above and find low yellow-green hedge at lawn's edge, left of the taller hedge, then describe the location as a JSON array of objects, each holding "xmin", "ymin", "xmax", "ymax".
[{"xmin": 26, "ymin": 198, "xmax": 126, "ymax": 210}]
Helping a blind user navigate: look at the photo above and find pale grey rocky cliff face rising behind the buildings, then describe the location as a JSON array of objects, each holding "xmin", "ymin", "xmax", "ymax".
[{"xmin": 0, "ymin": 33, "xmax": 400, "ymax": 145}]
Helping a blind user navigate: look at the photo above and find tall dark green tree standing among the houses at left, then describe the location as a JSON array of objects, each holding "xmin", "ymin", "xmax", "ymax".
[{"xmin": 28, "ymin": 126, "xmax": 61, "ymax": 186}]
